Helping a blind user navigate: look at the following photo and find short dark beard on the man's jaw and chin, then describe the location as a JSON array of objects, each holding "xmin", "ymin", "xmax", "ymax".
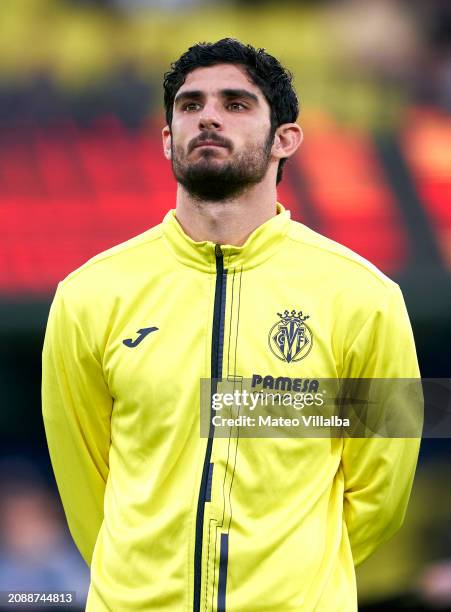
[{"xmin": 172, "ymin": 130, "xmax": 274, "ymax": 202}]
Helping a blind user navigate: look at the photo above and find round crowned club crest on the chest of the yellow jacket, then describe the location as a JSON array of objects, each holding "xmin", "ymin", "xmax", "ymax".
[{"xmin": 268, "ymin": 310, "xmax": 313, "ymax": 363}]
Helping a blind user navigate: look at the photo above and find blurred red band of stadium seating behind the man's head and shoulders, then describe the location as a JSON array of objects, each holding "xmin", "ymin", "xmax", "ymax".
[{"xmin": 0, "ymin": 109, "xmax": 451, "ymax": 296}]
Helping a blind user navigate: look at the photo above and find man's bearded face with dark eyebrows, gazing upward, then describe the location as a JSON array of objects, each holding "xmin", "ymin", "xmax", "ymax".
[{"xmin": 163, "ymin": 64, "xmax": 274, "ymax": 201}]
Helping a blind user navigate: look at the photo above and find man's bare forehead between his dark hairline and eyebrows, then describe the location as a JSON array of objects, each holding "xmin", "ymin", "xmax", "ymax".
[{"xmin": 177, "ymin": 64, "xmax": 265, "ymax": 100}]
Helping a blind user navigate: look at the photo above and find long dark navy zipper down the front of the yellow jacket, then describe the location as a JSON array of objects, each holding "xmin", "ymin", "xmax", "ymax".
[{"xmin": 193, "ymin": 244, "xmax": 227, "ymax": 612}]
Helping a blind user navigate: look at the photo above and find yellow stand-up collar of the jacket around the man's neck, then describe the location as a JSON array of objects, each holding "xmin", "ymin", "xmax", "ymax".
[{"xmin": 162, "ymin": 202, "xmax": 290, "ymax": 273}]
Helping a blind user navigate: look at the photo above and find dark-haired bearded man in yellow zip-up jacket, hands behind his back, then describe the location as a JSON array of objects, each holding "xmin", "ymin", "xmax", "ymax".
[{"xmin": 43, "ymin": 39, "xmax": 418, "ymax": 612}]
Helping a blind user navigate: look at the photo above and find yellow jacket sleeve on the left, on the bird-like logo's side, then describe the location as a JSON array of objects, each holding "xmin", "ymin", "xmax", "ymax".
[{"xmin": 42, "ymin": 285, "xmax": 112, "ymax": 565}]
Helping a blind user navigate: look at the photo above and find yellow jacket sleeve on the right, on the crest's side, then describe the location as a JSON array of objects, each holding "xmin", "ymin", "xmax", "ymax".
[{"xmin": 342, "ymin": 285, "xmax": 423, "ymax": 565}]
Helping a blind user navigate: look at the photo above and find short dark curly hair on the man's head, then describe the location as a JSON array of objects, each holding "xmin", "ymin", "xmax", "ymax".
[{"xmin": 163, "ymin": 38, "xmax": 299, "ymax": 184}]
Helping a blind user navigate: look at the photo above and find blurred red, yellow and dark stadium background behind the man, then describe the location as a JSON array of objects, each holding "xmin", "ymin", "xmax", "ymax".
[{"xmin": 0, "ymin": 0, "xmax": 451, "ymax": 611}]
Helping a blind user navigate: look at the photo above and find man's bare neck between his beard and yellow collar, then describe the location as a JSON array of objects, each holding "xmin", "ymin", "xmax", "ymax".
[{"xmin": 175, "ymin": 173, "xmax": 277, "ymax": 246}]
